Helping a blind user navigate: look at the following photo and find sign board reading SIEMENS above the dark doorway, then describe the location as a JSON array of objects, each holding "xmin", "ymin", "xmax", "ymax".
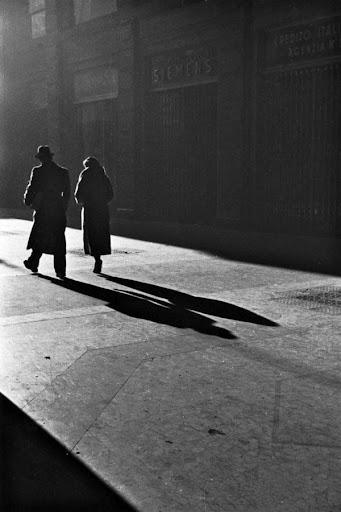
[{"xmin": 150, "ymin": 48, "xmax": 218, "ymax": 90}]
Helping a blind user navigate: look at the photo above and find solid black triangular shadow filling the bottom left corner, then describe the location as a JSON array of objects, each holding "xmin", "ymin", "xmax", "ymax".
[{"xmin": 0, "ymin": 394, "xmax": 137, "ymax": 512}]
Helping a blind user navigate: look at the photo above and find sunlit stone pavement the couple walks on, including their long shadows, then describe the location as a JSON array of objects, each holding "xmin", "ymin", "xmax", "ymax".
[{"xmin": 0, "ymin": 218, "xmax": 341, "ymax": 512}]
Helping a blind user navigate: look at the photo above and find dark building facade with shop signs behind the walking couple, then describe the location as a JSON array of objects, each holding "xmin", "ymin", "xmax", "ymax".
[{"xmin": 0, "ymin": 0, "xmax": 341, "ymax": 270}]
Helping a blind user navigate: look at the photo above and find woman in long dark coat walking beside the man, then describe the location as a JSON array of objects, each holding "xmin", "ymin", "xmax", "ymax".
[{"xmin": 75, "ymin": 156, "xmax": 113, "ymax": 273}]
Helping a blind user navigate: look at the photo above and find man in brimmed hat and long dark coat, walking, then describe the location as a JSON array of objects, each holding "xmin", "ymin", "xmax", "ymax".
[{"xmin": 24, "ymin": 146, "xmax": 70, "ymax": 278}]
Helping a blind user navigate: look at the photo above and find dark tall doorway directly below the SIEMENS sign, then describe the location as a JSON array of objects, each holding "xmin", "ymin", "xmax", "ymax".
[{"xmin": 141, "ymin": 83, "xmax": 217, "ymax": 223}]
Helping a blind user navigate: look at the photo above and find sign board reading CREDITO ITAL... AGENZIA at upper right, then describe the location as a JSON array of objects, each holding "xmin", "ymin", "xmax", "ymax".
[{"xmin": 260, "ymin": 16, "xmax": 341, "ymax": 67}]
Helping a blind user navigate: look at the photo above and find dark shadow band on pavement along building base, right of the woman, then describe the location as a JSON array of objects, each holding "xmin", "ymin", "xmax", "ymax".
[{"xmin": 112, "ymin": 219, "xmax": 341, "ymax": 275}]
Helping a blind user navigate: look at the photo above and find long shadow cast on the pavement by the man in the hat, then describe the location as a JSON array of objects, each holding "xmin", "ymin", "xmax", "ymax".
[{"xmin": 37, "ymin": 274, "xmax": 236, "ymax": 339}]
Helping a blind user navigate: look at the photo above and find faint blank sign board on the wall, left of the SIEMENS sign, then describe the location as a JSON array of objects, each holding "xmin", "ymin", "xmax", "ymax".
[{"xmin": 74, "ymin": 67, "xmax": 118, "ymax": 103}]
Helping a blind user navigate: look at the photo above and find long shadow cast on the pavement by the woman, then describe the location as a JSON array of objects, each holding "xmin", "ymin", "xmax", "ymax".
[{"xmin": 101, "ymin": 274, "xmax": 278, "ymax": 327}]
